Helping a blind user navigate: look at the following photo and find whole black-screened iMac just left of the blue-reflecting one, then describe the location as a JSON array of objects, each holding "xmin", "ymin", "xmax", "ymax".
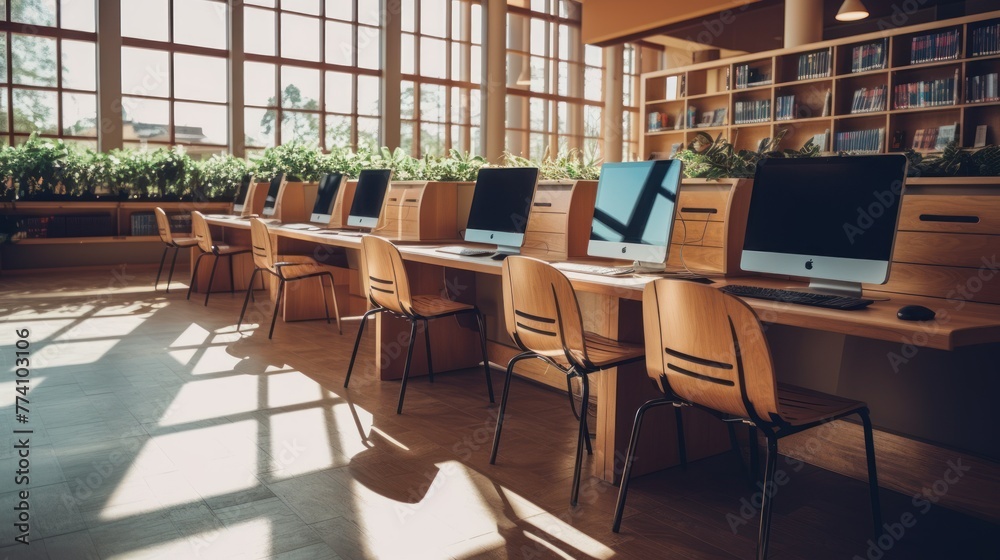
[{"xmin": 465, "ymin": 167, "xmax": 538, "ymax": 254}]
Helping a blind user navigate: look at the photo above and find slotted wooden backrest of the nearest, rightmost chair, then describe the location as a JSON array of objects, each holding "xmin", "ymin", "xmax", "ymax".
[{"xmin": 642, "ymin": 279, "xmax": 781, "ymax": 422}]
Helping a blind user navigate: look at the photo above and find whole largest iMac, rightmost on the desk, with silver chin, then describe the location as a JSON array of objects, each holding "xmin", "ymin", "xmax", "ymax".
[{"xmin": 740, "ymin": 154, "xmax": 907, "ymax": 296}]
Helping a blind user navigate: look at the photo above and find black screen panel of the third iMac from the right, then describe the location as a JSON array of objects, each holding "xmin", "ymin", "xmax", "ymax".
[{"xmin": 467, "ymin": 167, "xmax": 538, "ymax": 233}]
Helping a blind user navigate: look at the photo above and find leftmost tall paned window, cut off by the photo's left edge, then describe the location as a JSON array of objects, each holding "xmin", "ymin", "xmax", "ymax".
[{"xmin": 0, "ymin": 0, "xmax": 98, "ymax": 147}]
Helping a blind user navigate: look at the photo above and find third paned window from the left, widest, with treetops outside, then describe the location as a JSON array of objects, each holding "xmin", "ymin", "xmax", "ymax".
[{"xmin": 244, "ymin": 0, "xmax": 381, "ymax": 150}]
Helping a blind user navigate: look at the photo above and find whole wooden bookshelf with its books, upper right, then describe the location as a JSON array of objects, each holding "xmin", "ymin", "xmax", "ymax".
[{"xmin": 640, "ymin": 11, "xmax": 1000, "ymax": 158}]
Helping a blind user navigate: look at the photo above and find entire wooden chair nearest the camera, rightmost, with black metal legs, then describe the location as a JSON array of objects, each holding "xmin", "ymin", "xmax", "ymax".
[{"xmin": 612, "ymin": 279, "xmax": 882, "ymax": 559}]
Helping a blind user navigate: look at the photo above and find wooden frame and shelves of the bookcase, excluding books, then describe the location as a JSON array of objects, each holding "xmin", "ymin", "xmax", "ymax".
[{"xmin": 640, "ymin": 11, "xmax": 1000, "ymax": 158}]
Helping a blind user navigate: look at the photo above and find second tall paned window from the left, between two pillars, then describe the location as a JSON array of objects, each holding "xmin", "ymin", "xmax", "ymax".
[{"xmin": 120, "ymin": 0, "xmax": 229, "ymax": 154}]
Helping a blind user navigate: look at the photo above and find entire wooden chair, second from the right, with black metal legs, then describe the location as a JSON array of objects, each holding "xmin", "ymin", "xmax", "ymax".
[{"xmin": 490, "ymin": 256, "xmax": 643, "ymax": 505}]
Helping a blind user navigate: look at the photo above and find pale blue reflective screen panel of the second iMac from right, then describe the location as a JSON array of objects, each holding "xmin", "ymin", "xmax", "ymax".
[{"xmin": 590, "ymin": 160, "xmax": 681, "ymax": 245}]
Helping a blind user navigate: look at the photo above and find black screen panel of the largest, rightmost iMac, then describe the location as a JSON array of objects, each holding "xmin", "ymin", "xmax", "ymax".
[{"xmin": 743, "ymin": 155, "xmax": 906, "ymax": 261}]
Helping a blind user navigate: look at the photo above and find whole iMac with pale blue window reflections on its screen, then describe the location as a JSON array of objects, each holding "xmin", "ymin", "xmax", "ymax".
[{"xmin": 587, "ymin": 160, "xmax": 681, "ymax": 271}]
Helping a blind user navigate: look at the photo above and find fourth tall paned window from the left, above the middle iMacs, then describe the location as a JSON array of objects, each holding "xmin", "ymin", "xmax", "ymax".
[{"xmin": 400, "ymin": 0, "xmax": 482, "ymax": 156}]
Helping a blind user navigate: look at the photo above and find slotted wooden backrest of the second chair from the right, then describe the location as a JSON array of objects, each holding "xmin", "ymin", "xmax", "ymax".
[{"xmin": 502, "ymin": 256, "xmax": 593, "ymax": 369}]
